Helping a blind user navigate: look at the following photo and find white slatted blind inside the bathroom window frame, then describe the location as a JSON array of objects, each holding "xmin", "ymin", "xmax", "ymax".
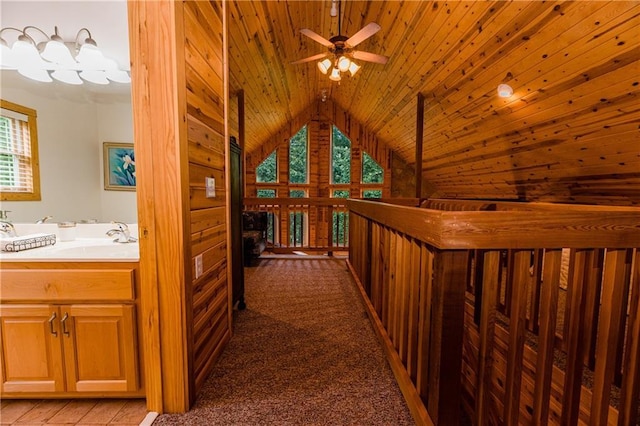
[{"xmin": 0, "ymin": 108, "xmax": 34, "ymax": 193}]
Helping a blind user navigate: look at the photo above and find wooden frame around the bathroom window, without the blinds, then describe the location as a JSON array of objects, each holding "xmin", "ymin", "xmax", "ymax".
[{"xmin": 0, "ymin": 99, "xmax": 42, "ymax": 201}]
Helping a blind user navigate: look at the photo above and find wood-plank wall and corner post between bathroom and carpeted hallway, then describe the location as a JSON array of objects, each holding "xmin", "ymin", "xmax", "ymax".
[{"xmin": 129, "ymin": 0, "xmax": 231, "ymax": 412}]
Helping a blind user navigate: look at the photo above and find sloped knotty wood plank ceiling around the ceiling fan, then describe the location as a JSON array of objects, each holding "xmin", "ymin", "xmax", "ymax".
[{"xmin": 229, "ymin": 0, "xmax": 640, "ymax": 205}]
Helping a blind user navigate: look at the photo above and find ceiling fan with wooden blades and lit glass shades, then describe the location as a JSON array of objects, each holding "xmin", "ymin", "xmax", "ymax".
[{"xmin": 291, "ymin": 2, "xmax": 389, "ymax": 81}]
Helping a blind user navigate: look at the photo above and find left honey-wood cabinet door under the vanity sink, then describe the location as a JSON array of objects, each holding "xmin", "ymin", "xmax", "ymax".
[{"xmin": 0, "ymin": 305, "xmax": 64, "ymax": 392}]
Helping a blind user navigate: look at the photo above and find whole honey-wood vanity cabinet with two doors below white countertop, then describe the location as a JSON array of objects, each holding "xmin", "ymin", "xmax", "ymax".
[{"xmin": 0, "ymin": 262, "xmax": 142, "ymax": 397}]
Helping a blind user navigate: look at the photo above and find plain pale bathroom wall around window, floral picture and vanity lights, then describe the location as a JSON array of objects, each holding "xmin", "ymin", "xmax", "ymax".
[{"xmin": 0, "ymin": 0, "xmax": 137, "ymax": 223}]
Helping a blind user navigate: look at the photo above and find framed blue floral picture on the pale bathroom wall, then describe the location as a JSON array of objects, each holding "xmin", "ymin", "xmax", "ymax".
[{"xmin": 102, "ymin": 142, "xmax": 136, "ymax": 191}]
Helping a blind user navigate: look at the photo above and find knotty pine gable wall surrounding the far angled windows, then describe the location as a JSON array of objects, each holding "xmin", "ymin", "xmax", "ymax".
[{"xmin": 245, "ymin": 100, "xmax": 392, "ymax": 198}]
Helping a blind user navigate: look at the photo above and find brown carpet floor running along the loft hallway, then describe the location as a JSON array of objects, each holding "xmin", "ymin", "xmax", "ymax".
[{"xmin": 153, "ymin": 259, "xmax": 414, "ymax": 426}]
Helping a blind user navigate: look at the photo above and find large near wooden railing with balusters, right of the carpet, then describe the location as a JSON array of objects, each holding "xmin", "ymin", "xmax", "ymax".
[{"xmin": 348, "ymin": 200, "xmax": 640, "ymax": 425}]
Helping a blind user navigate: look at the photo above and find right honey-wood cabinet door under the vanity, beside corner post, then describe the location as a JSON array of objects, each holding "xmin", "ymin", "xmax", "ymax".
[{"xmin": 60, "ymin": 304, "xmax": 139, "ymax": 392}]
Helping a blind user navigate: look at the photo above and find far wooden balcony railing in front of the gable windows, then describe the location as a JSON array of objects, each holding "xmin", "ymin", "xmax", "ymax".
[{"xmin": 244, "ymin": 198, "xmax": 349, "ymax": 254}]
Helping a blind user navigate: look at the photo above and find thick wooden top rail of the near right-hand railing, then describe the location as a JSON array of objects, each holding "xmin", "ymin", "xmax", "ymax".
[{"xmin": 347, "ymin": 199, "xmax": 640, "ymax": 249}]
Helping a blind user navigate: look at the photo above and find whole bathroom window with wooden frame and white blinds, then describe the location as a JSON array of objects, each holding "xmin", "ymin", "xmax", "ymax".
[{"xmin": 0, "ymin": 100, "xmax": 40, "ymax": 201}]
